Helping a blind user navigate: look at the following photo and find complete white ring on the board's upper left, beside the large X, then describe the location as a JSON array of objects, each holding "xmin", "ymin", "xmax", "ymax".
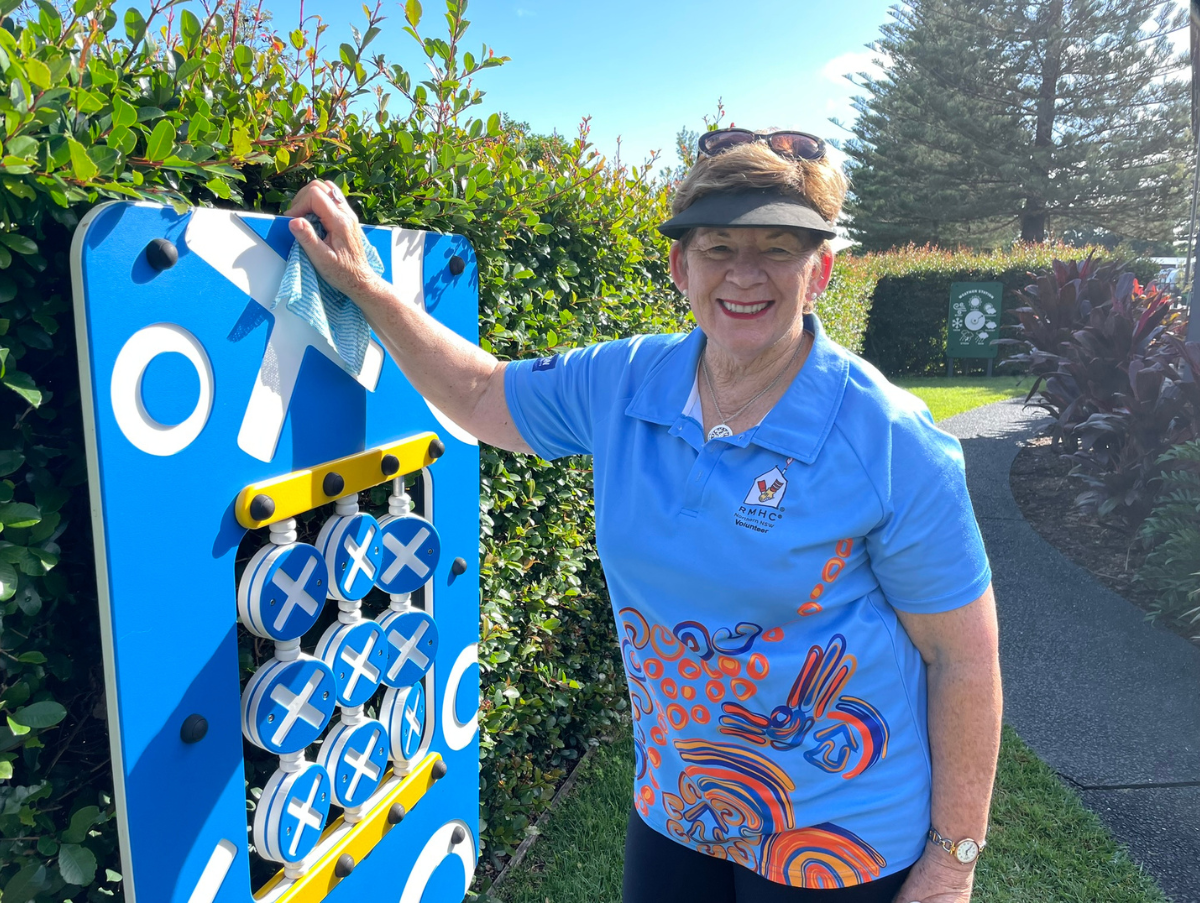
[{"xmin": 112, "ymin": 323, "xmax": 212, "ymax": 458}]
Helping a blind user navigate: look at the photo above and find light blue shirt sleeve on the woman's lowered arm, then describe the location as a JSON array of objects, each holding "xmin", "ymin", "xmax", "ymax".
[{"xmin": 866, "ymin": 405, "xmax": 991, "ymax": 614}]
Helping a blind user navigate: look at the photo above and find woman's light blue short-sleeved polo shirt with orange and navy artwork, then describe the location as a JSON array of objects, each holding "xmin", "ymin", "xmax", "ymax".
[{"xmin": 505, "ymin": 316, "xmax": 991, "ymax": 887}]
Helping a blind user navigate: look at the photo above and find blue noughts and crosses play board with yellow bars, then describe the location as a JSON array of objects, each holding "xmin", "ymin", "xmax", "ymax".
[{"xmin": 71, "ymin": 202, "xmax": 479, "ymax": 903}]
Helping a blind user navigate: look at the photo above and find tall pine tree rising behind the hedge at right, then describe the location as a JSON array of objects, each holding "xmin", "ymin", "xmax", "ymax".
[{"xmin": 845, "ymin": 0, "xmax": 1193, "ymax": 249}]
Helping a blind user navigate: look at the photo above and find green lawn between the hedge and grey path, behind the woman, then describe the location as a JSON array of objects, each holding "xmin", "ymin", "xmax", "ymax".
[{"xmin": 484, "ymin": 376, "xmax": 1166, "ymax": 903}]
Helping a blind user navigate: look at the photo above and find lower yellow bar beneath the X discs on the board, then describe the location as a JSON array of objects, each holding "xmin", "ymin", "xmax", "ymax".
[{"xmin": 254, "ymin": 753, "xmax": 442, "ymax": 903}]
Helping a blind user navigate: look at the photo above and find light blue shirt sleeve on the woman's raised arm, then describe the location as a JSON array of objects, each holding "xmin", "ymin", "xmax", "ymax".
[{"xmin": 504, "ymin": 342, "xmax": 607, "ymax": 461}]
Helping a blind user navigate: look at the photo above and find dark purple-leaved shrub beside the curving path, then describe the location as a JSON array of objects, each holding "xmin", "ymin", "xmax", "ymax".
[{"xmin": 1006, "ymin": 257, "xmax": 1200, "ymax": 525}]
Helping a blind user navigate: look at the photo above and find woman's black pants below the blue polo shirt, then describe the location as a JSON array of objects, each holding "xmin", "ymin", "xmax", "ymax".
[{"xmin": 622, "ymin": 809, "xmax": 912, "ymax": 903}]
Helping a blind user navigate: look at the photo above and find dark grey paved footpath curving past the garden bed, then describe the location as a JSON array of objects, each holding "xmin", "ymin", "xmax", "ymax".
[{"xmin": 938, "ymin": 400, "xmax": 1200, "ymax": 903}]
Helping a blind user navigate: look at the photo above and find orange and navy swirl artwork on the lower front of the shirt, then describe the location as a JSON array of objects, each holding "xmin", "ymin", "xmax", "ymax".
[{"xmin": 618, "ymin": 608, "xmax": 888, "ymax": 887}]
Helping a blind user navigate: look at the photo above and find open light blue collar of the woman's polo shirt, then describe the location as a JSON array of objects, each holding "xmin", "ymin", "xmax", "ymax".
[{"xmin": 625, "ymin": 313, "xmax": 850, "ymax": 464}]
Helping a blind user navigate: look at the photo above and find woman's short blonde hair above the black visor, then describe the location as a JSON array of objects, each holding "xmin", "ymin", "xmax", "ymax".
[{"xmin": 671, "ymin": 138, "xmax": 850, "ymax": 246}]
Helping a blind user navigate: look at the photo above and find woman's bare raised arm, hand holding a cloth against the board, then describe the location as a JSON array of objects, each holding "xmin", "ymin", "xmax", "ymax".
[{"xmin": 284, "ymin": 180, "xmax": 532, "ymax": 452}]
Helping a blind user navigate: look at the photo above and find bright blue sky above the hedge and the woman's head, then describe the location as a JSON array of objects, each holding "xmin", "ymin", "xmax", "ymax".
[{"xmin": 250, "ymin": 0, "xmax": 894, "ymax": 166}]
